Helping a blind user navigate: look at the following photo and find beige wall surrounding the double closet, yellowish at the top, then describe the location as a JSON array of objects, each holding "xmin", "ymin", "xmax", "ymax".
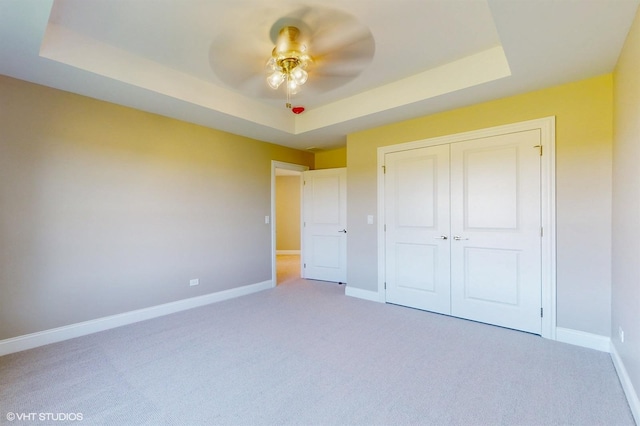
[{"xmin": 347, "ymin": 75, "xmax": 612, "ymax": 336}]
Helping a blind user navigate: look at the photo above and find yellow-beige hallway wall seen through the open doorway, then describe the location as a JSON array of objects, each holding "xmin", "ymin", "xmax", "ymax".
[{"xmin": 276, "ymin": 176, "xmax": 302, "ymax": 250}]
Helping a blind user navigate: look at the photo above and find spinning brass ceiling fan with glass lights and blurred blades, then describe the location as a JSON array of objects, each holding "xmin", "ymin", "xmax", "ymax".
[{"xmin": 209, "ymin": 6, "xmax": 375, "ymax": 113}]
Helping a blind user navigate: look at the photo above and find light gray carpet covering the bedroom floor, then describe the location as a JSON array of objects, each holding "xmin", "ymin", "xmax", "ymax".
[{"xmin": 0, "ymin": 280, "xmax": 634, "ymax": 425}]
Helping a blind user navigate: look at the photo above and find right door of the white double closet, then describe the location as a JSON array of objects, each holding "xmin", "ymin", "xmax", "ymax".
[{"xmin": 451, "ymin": 129, "xmax": 542, "ymax": 334}]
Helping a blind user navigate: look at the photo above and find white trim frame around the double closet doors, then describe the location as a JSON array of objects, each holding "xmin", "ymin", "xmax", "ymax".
[{"xmin": 377, "ymin": 116, "xmax": 556, "ymax": 340}]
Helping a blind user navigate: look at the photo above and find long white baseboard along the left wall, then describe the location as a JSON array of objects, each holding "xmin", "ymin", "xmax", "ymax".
[{"xmin": 0, "ymin": 280, "xmax": 273, "ymax": 356}]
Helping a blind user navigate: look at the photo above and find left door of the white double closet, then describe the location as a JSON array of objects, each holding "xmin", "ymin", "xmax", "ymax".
[{"xmin": 385, "ymin": 145, "xmax": 450, "ymax": 314}]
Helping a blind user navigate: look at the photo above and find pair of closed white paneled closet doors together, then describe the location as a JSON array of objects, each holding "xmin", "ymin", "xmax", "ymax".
[{"xmin": 384, "ymin": 129, "xmax": 542, "ymax": 334}]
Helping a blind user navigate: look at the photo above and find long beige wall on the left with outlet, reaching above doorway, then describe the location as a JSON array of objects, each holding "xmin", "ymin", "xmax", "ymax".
[{"xmin": 0, "ymin": 77, "xmax": 313, "ymax": 340}]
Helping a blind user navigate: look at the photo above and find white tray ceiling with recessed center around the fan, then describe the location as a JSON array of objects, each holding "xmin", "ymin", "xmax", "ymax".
[{"xmin": 0, "ymin": 0, "xmax": 640, "ymax": 149}]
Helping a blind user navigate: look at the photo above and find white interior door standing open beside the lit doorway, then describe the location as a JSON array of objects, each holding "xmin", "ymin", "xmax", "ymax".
[{"xmin": 302, "ymin": 168, "xmax": 347, "ymax": 283}]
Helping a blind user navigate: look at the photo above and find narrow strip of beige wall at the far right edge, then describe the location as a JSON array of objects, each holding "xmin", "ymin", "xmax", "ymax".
[{"xmin": 611, "ymin": 5, "xmax": 640, "ymax": 414}]
